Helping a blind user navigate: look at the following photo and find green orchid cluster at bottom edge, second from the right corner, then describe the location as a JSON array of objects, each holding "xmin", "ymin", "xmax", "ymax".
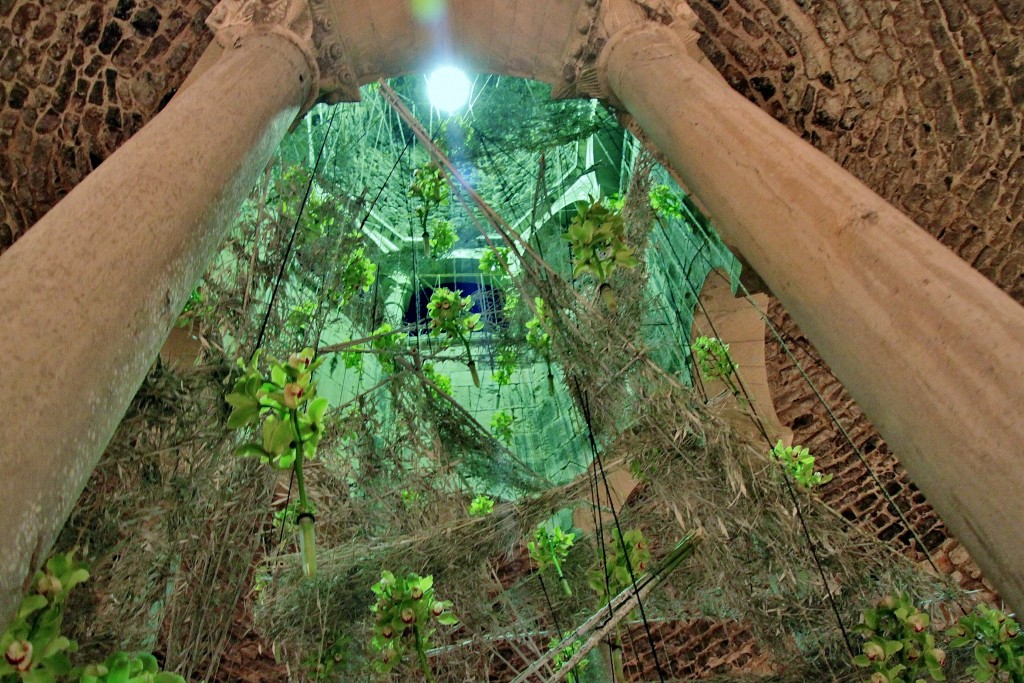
[{"xmin": 853, "ymin": 593, "xmax": 946, "ymax": 683}]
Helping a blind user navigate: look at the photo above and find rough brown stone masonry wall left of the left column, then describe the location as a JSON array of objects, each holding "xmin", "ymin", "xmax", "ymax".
[{"xmin": 0, "ymin": 0, "xmax": 213, "ymax": 252}]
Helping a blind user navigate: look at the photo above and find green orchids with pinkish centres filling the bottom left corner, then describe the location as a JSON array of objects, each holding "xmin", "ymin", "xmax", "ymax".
[{"xmin": 0, "ymin": 553, "xmax": 184, "ymax": 683}]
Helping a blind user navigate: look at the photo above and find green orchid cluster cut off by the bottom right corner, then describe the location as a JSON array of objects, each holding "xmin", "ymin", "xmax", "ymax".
[{"xmin": 946, "ymin": 605, "xmax": 1024, "ymax": 683}]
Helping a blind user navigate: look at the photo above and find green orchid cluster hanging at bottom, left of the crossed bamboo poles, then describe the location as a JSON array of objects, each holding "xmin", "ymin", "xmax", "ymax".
[{"xmin": 370, "ymin": 569, "xmax": 459, "ymax": 681}]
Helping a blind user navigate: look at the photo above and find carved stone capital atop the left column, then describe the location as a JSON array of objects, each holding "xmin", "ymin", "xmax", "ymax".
[{"xmin": 206, "ymin": 0, "xmax": 359, "ymax": 116}]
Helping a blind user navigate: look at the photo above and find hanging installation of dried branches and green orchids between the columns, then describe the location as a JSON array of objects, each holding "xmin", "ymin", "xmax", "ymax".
[{"xmin": 37, "ymin": 77, "xmax": 983, "ymax": 683}]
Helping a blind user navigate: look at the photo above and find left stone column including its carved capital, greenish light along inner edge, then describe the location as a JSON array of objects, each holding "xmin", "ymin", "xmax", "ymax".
[{"xmin": 0, "ymin": 0, "xmax": 316, "ymax": 629}]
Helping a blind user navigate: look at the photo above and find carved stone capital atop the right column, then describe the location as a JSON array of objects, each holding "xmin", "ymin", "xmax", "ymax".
[{"xmin": 553, "ymin": 0, "xmax": 705, "ymax": 104}]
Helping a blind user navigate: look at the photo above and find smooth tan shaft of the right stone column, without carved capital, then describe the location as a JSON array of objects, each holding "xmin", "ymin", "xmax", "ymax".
[{"xmin": 598, "ymin": 23, "xmax": 1024, "ymax": 611}]
